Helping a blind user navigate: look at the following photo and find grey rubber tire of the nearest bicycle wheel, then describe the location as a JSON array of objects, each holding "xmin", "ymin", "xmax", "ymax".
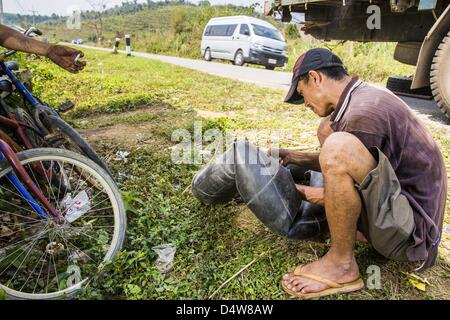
[{"xmin": 0, "ymin": 148, "xmax": 127, "ymax": 299}]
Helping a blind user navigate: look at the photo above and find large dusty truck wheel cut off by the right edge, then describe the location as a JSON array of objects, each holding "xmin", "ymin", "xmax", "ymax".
[{"xmin": 430, "ymin": 32, "xmax": 450, "ymax": 118}]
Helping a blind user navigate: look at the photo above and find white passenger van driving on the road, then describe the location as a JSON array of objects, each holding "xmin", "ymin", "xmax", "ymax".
[{"xmin": 200, "ymin": 16, "xmax": 288, "ymax": 70}]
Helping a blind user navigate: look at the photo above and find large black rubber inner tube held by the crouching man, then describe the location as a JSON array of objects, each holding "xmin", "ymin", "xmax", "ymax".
[{"xmin": 192, "ymin": 141, "xmax": 328, "ymax": 240}]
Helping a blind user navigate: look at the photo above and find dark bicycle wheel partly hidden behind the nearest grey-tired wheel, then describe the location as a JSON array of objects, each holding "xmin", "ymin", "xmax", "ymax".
[{"xmin": 44, "ymin": 115, "xmax": 113, "ymax": 177}]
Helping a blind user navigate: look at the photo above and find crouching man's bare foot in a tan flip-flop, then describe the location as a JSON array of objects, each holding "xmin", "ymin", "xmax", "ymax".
[{"xmin": 283, "ymin": 253, "xmax": 359, "ymax": 293}]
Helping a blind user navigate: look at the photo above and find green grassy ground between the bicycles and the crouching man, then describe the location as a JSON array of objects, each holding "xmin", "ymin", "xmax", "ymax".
[{"xmin": 18, "ymin": 50, "xmax": 450, "ymax": 299}]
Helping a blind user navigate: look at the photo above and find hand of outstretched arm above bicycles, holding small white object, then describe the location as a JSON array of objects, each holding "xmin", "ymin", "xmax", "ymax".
[{"xmin": 45, "ymin": 45, "xmax": 86, "ymax": 73}]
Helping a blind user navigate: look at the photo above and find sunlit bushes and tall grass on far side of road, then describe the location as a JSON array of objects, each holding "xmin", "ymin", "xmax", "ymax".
[{"xmin": 40, "ymin": 1, "xmax": 414, "ymax": 84}]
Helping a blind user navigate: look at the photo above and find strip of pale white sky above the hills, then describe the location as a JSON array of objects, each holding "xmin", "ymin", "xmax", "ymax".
[{"xmin": 3, "ymin": 0, "xmax": 264, "ymax": 15}]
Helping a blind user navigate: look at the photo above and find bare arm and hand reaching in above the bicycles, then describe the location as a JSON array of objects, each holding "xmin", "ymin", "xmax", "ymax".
[{"xmin": 0, "ymin": 24, "xmax": 86, "ymax": 73}]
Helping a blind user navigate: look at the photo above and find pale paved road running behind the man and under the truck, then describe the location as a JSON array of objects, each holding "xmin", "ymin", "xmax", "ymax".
[{"xmin": 80, "ymin": 45, "xmax": 450, "ymax": 127}]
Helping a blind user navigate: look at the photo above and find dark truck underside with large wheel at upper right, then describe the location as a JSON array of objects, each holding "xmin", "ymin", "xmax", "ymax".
[{"xmin": 265, "ymin": 0, "xmax": 450, "ymax": 117}]
